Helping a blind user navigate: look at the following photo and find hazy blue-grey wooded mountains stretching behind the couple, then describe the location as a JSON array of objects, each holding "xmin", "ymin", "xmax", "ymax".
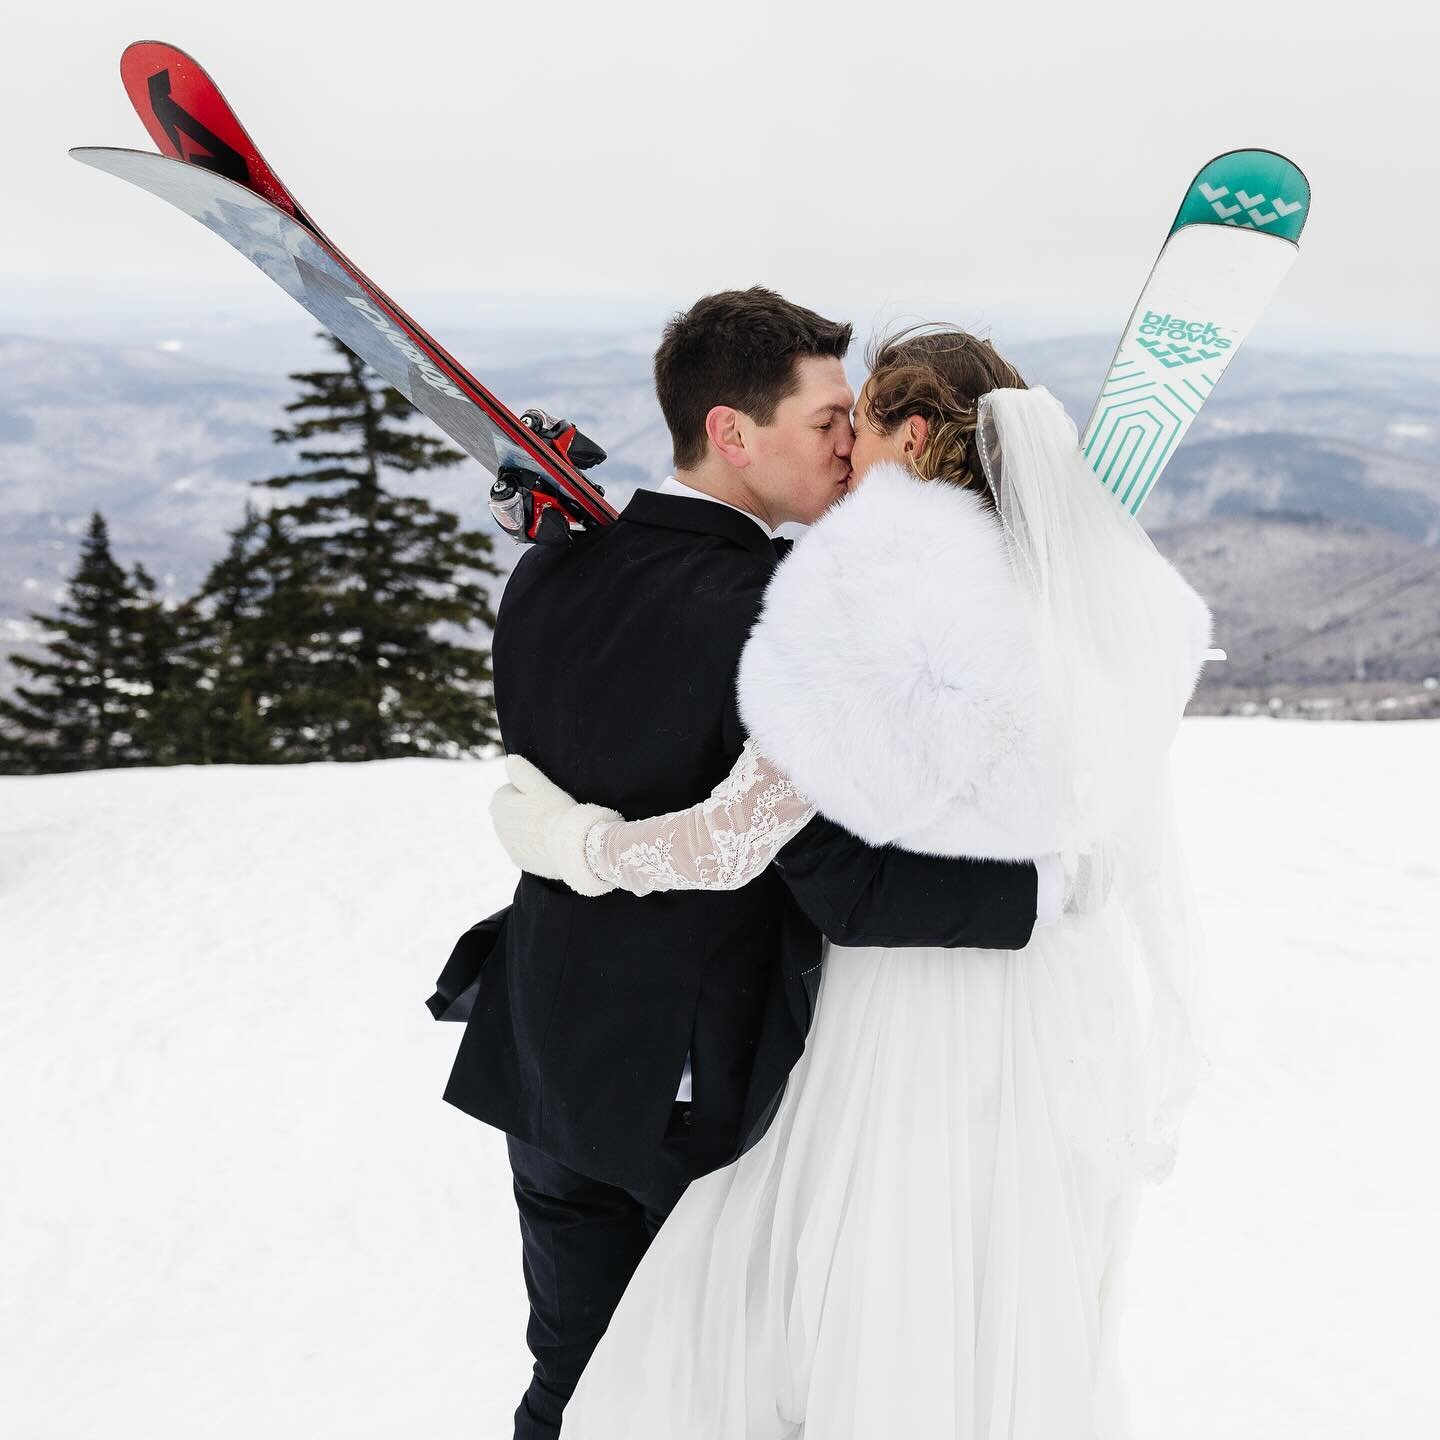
[{"xmin": 0, "ymin": 321, "xmax": 1440, "ymax": 685}]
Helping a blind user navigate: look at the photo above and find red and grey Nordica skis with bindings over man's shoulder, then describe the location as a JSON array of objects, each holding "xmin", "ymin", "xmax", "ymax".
[{"xmin": 71, "ymin": 40, "xmax": 616, "ymax": 540}]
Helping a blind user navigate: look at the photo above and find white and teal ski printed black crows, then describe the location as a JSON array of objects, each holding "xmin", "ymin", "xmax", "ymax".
[{"xmin": 1080, "ymin": 150, "xmax": 1310, "ymax": 514}]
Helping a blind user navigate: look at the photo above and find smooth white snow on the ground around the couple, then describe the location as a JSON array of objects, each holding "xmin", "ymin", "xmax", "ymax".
[{"xmin": 0, "ymin": 720, "xmax": 1440, "ymax": 1440}]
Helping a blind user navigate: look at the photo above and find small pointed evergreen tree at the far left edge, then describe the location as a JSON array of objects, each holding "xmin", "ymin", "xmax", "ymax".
[{"xmin": 0, "ymin": 511, "xmax": 158, "ymax": 773}]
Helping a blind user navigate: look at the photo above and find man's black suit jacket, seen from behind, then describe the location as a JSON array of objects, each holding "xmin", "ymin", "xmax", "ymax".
[{"xmin": 431, "ymin": 491, "xmax": 1035, "ymax": 1189}]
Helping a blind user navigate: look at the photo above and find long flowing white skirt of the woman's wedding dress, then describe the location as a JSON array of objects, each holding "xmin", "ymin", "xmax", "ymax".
[{"xmin": 564, "ymin": 914, "xmax": 1142, "ymax": 1440}]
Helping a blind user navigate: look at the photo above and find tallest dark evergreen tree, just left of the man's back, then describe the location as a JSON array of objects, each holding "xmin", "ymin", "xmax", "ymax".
[{"xmin": 262, "ymin": 336, "xmax": 500, "ymax": 760}]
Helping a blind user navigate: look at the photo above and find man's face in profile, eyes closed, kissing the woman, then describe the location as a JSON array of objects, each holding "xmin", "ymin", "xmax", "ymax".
[{"xmin": 749, "ymin": 356, "xmax": 855, "ymax": 526}]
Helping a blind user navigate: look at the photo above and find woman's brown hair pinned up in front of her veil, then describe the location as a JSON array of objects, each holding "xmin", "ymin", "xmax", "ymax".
[{"xmin": 865, "ymin": 325, "xmax": 1028, "ymax": 508}]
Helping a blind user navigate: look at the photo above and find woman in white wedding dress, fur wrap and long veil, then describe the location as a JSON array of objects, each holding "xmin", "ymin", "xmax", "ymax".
[{"xmin": 495, "ymin": 330, "xmax": 1210, "ymax": 1440}]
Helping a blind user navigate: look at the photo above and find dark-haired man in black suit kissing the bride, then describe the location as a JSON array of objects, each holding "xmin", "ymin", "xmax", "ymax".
[{"xmin": 431, "ymin": 288, "xmax": 1051, "ymax": 1440}]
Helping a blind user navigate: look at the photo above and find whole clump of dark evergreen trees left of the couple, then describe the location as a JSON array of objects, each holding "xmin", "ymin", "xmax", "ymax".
[{"xmin": 0, "ymin": 336, "xmax": 498, "ymax": 772}]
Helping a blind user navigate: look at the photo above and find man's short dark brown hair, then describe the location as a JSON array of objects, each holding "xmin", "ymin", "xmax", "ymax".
[{"xmin": 655, "ymin": 285, "xmax": 851, "ymax": 469}]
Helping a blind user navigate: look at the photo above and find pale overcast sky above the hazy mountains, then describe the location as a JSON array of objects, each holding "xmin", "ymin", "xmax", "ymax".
[{"xmin": 8, "ymin": 0, "xmax": 1440, "ymax": 351}]
